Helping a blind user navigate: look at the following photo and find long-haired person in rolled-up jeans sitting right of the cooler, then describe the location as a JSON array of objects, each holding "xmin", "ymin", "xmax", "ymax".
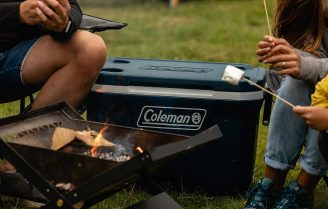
[{"xmin": 244, "ymin": 0, "xmax": 328, "ymax": 209}]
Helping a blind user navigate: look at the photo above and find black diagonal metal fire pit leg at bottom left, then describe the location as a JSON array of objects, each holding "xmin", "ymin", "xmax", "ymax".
[{"xmin": 0, "ymin": 139, "xmax": 74, "ymax": 209}]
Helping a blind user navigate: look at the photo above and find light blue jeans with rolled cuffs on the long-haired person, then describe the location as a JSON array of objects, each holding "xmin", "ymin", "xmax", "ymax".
[{"xmin": 264, "ymin": 76, "xmax": 327, "ymax": 175}]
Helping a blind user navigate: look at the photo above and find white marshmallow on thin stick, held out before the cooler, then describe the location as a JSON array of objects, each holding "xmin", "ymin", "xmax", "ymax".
[{"xmin": 222, "ymin": 65, "xmax": 295, "ymax": 108}]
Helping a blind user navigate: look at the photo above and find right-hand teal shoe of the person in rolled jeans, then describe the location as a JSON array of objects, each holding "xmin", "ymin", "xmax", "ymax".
[{"xmin": 274, "ymin": 180, "xmax": 314, "ymax": 209}]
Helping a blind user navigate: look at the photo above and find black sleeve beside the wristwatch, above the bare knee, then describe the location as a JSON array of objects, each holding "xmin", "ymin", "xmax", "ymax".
[{"xmin": 50, "ymin": 0, "xmax": 82, "ymax": 40}]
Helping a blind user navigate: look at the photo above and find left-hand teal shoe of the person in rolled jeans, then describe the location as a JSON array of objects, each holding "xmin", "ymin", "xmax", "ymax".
[{"xmin": 244, "ymin": 178, "xmax": 279, "ymax": 209}]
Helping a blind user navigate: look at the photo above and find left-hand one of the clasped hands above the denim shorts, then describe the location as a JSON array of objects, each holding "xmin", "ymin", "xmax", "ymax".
[{"xmin": 19, "ymin": 0, "xmax": 41, "ymax": 25}]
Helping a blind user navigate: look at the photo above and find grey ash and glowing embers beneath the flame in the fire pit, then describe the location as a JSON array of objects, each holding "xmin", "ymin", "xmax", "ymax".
[{"xmin": 82, "ymin": 144, "xmax": 132, "ymax": 162}]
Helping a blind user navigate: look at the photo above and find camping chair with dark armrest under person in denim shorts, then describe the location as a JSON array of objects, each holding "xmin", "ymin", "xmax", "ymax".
[{"xmin": 0, "ymin": 14, "xmax": 127, "ymax": 115}]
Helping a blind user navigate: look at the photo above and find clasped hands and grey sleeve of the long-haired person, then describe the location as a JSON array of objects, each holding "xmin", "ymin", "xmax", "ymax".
[{"xmin": 256, "ymin": 30, "xmax": 328, "ymax": 84}]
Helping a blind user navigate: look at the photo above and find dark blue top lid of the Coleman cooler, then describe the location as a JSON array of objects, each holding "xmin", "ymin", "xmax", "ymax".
[{"xmin": 96, "ymin": 57, "xmax": 265, "ymax": 92}]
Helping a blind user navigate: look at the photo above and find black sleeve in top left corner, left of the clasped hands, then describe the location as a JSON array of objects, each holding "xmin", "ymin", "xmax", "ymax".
[{"xmin": 0, "ymin": 2, "xmax": 20, "ymax": 31}]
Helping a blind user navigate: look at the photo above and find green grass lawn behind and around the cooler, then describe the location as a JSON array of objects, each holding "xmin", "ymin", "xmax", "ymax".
[{"xmin": 0, "ymin": 0, "xmax": 328, "ymax": 209}]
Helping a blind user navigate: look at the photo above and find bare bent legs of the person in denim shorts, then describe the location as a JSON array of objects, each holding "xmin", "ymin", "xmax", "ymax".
[{"xmin": 22, "ymin": 31, "xmax": 106, "ymax": 109}]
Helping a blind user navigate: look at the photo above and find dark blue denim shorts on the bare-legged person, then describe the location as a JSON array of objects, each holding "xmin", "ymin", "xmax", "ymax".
[{"xmin": 0, "ymin": 38, "xmax": 41, "ymax": 102}]
